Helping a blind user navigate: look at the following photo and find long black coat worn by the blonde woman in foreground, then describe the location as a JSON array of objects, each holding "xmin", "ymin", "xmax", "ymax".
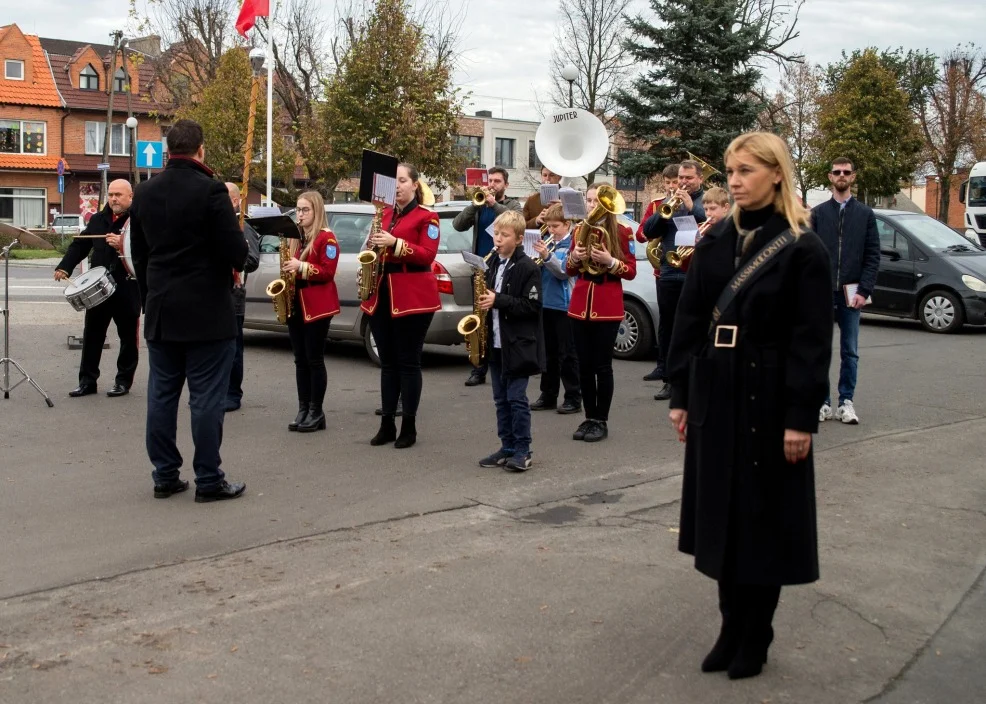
[{"xmin": 668, "ymin": 208, "xmax": 832, "ymax": 584}]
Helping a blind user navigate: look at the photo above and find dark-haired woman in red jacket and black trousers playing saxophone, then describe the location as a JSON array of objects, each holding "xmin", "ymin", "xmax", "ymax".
[{"xmin": 360, "ymin": 164, "xmax": 442, "ymax": 448}]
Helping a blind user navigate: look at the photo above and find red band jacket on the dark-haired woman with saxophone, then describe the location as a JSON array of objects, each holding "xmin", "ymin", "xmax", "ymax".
[{"xmin": 360, "ymin": 201, "xmax": 442, "ymax": 318}]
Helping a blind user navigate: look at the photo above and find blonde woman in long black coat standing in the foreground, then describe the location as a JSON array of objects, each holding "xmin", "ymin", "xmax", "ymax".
[{"xmin": 668, "ymin": 132, "xmax": 832, "ymax": 679}]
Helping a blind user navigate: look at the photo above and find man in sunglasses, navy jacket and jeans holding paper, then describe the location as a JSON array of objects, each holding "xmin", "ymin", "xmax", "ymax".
[{"xmin": 811, "ymin": 158, "xmax": 880, "ymax": 425}]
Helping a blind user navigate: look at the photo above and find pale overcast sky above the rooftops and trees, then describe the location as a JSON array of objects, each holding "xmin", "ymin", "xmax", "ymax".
[{"xmin": 0, "ymin": 0, "xmax": 986, "ymax": 120}]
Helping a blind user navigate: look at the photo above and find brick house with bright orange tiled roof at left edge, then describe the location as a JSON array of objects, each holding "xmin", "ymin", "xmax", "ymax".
[{"xmin": 0, "ymin": 25, "xmax": 65, "ymax": 228}]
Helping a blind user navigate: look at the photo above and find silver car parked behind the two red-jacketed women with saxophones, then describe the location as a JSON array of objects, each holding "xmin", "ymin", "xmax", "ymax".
[{"xmin": 243, "ymin": 204, "xmax": 472, "ymax": 363}]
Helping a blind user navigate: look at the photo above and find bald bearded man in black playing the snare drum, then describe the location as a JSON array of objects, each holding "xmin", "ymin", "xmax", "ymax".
[{"xmin": 55, "ymin": 179, "xmax": 140, "ymax": 397}]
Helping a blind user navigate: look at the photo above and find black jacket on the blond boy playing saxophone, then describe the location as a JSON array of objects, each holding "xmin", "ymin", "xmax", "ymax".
[{"xmin": 486, "ymin": 246, "xmax": 545, "ymax": 379}]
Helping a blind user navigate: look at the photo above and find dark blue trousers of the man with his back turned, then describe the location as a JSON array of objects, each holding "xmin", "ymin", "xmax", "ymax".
[{"xmin": 146, "ymin": 340, "xmax": 236, "ymax": 491}]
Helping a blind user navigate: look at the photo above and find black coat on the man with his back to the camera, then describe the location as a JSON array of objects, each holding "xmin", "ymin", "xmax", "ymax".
[{"xmin": 130, "ymin": 157, "xmax": 247, "ymax": 342}]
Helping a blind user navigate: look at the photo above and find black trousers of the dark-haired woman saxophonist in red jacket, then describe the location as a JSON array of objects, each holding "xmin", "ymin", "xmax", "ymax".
[{"xmin": 370, "ymin": 305, "xmax": 435, "ymax": 418}]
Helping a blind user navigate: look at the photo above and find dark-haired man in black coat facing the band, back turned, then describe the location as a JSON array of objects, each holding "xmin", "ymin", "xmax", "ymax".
[{"xmin": 131, "ymin": 120, "xmax": 247, "ymax": 502}]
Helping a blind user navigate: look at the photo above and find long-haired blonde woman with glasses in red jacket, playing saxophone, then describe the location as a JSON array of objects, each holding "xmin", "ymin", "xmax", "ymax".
[{"xmin": 283, "ymin": 191, "xmax": 339, "ymax": 433}]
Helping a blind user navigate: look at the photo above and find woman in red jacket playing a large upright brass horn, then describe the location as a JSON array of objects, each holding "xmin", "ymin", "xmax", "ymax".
[{"xmin": 565, "ymin": 184, "xmax": 637, "ymax": 442}]
